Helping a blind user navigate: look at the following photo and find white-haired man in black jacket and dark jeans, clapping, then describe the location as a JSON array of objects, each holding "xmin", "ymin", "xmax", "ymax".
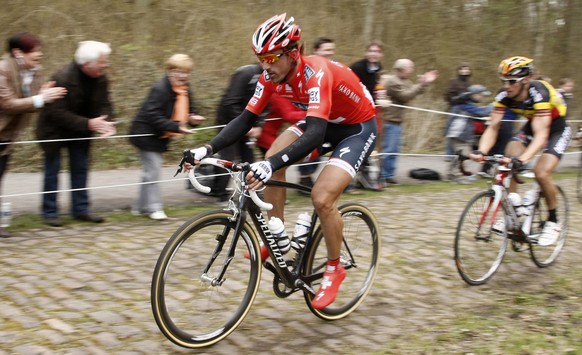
[{"xmin": 37, "ymin": 41, "xmax": 116, "ymax": 227}]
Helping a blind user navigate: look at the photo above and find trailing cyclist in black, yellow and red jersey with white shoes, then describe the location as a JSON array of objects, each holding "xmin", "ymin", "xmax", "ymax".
[{"xmin": 471, "ymin": 56, "xmax": 572, "ymax": 245}]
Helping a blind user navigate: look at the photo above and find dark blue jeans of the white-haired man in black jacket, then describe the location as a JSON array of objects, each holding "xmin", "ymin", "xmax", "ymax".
[{"xmin": 42, "ymin": 140, "xmax": 89, "ymax": 218}]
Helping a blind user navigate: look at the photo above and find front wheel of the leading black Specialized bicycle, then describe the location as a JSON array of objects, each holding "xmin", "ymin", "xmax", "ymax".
[{"xmin": 151, "ymin": 211, "xmax": 261, "ymax": 348}]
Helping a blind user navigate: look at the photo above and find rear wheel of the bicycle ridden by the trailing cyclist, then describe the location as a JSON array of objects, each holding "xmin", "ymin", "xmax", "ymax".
[{"xmin": 529, "ymin": 185, "xmax": 570, "ymax": 268}]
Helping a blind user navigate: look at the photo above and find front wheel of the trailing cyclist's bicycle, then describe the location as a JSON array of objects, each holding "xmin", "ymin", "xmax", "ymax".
[{"xmin": 455, "ymin": 190, "xmax": 508, "ymax": 285}]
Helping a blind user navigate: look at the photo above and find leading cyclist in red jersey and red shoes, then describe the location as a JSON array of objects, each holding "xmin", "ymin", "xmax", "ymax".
[{"xmin": 185, "ymin": 14, "xmax": 376, "ymax": 309}]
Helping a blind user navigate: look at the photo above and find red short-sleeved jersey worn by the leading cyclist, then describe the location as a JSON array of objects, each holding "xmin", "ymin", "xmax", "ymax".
[{"xmin": 246, "ymin": 56, "xmax": 376, "ymax": 124}]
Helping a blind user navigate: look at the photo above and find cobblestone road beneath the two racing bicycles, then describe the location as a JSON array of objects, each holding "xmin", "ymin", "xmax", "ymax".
[{"xmin": 0, "ymin": 180, "xmax": 582, "ymax": 354}]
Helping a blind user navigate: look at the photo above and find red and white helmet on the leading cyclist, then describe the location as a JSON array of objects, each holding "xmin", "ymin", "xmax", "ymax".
[{"xmin": 252, "ymin": 13, "xmax": 301, "ymax": 55}]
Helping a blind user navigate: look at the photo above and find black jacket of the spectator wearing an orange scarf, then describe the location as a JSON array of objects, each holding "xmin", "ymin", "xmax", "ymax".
[{"xmin": 129, "ymin": 76, "xmax": 195, "ymax": 153}]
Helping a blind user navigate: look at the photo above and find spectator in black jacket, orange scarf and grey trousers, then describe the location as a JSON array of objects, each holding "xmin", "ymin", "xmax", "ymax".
[{"xmin": 129, "ymin": 54, "xmax": 205, "ymax": 220}]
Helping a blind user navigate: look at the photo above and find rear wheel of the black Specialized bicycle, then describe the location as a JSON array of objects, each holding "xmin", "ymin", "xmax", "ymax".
[{"xmin": 303, "ymin": 203, "xmax": 381, "ymax": 320}]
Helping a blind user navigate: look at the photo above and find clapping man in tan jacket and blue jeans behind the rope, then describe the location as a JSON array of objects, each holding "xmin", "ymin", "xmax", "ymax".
[{"xmin": 380, "ymin": 59, "xmax": 439, "ymax": 184}]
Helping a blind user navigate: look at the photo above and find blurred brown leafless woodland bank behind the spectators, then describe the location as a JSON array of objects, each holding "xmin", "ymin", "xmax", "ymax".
[{"xmin": 0, "ymin": 0, "xmax": 582, "ymax": 170}]
